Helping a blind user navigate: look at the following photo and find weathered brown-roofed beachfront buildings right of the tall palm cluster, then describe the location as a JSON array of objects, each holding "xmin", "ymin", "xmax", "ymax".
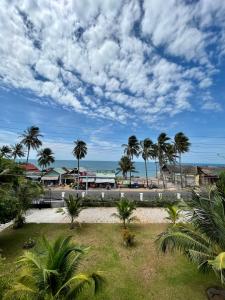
[{"xmin": 162, "ymin": 165, "xmax": 225, "ymax": 187}]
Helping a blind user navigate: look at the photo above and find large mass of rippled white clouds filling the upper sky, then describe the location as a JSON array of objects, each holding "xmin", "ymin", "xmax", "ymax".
[{"xmin": 0, "ymin": 0, "xmax": 225, "ymax": 123}]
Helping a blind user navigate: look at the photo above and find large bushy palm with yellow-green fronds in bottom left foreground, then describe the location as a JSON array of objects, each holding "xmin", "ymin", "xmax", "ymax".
[{"xmin": 6, "ymin": 236, "xmax": 103, "ymax": 300}]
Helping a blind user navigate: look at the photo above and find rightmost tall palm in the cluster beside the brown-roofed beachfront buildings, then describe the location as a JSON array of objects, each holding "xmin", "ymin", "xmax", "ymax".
[{"xmin": 174, "ymin": 132, "xmax": 191, "ymax": 188}]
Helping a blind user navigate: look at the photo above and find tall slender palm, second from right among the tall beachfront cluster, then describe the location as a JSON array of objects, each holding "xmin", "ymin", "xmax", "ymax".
[{"xmin": 157, "ymin": 132, "xmax": 170, "ymax": 188}]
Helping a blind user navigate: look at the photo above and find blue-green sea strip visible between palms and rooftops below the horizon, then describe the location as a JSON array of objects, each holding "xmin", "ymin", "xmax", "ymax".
[{"xmin": 23, "ymin": 159, "xmax": 224, "ymax": 177}]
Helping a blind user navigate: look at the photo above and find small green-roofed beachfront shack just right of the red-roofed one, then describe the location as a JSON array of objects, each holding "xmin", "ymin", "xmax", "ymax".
[{"xmin": 41, "ymin": 168, "xmax": 68, "ymax": 185}]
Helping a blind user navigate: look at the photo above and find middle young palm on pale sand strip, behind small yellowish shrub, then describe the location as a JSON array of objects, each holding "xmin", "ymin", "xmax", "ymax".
[{"xmin": 112, "ymin": 198, "xmax": 137, "ymax": 228}]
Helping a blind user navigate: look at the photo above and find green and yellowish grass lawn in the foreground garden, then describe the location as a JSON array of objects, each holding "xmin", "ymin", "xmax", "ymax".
[{"xmin": 0, "ymin": 224, "xmax": 219, "ymax": 300}]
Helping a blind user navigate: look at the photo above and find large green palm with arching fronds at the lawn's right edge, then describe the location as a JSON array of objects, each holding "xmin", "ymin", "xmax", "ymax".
[{"xmin": 157, "ymin": 191, "xmax": 225, "ymax": 284}]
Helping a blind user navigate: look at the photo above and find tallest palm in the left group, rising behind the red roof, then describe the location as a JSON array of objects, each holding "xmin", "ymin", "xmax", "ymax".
[{"xmin": 21, "ymin": 126, "xmax": 42, "ymax": 163}]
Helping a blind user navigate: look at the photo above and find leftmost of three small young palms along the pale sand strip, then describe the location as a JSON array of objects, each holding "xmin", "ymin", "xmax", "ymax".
[{"xmin": 65, "ymin": 194, "xmax": 83, "ymax": 229}]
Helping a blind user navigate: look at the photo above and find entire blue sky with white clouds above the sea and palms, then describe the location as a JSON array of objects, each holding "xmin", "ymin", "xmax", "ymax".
[{"xmin": 0, "ymin": 0, "xmax": 225, "ymax": 163}]
